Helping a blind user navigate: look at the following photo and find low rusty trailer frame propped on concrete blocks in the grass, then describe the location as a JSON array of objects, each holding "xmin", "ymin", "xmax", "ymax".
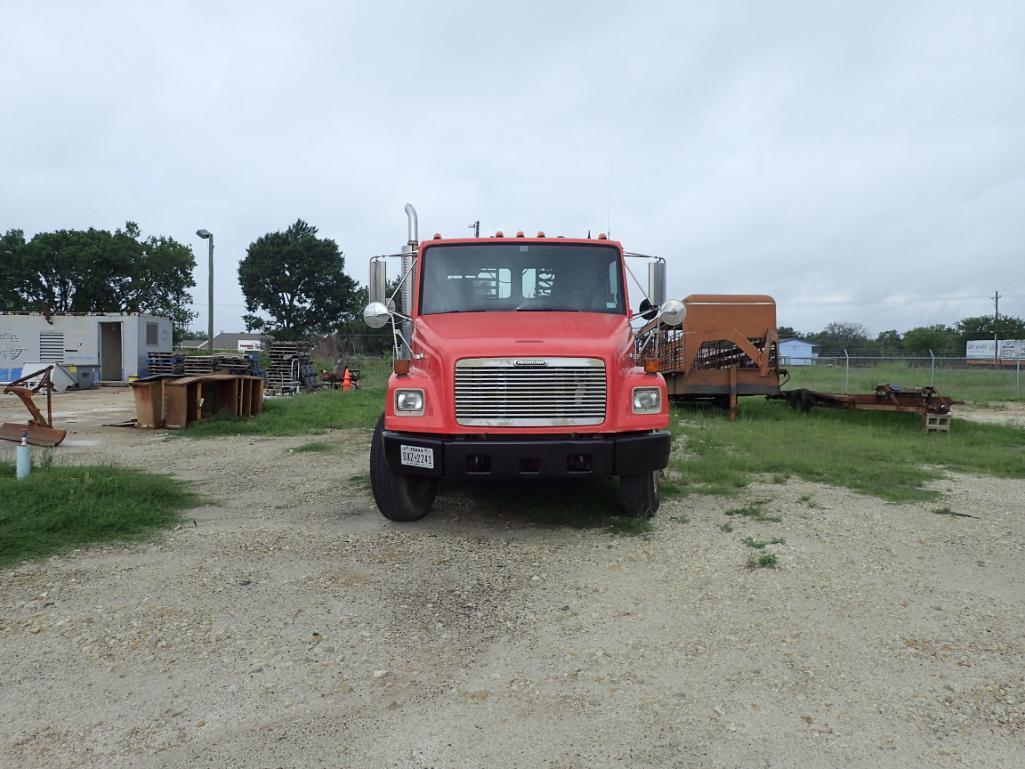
[{"xmin": 769, "ymin": 385, "xmax": 965, "ymax": 432}]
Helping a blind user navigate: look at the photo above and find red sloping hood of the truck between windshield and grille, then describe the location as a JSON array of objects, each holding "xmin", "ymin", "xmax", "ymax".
[{"xmin": 414, "ymin": 312, "xmax": 630, "ymax": 363}]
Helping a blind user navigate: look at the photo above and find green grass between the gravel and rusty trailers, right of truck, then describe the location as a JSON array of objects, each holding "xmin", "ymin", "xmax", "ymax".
[{"xmin": 671, "ymin": 398, "xmax": 1025, "ymax": 501}]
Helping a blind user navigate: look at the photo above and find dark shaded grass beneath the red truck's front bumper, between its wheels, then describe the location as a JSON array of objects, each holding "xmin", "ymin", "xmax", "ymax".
[{"xmin": 441, "ymin": 479, "xmax": 653, "ymax": 536}]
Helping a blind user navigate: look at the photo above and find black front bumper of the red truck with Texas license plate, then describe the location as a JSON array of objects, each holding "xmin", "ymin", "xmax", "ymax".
[{"xmin": 383, "ymin": 430, "xmax": 670, "ymax": 480}]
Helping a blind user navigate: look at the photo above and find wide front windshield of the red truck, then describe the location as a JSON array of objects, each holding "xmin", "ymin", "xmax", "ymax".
[{"xmin": 420, "ymin": 248, "xmax": 626, "ymax": 315}]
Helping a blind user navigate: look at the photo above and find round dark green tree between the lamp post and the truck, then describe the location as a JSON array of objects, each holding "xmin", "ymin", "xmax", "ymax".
[{"xmin": 239, "ymin": 219, "xmax": 363, "ymax": 339}]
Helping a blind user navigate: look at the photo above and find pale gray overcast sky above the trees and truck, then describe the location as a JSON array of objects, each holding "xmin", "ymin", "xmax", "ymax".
[{"xmin": 0, "ymin": 0, "xmax": 1025, "ymax": 333}]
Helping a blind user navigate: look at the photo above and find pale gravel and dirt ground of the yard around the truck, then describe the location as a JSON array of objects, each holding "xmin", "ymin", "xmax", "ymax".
[{"xmin": 0, "ymin": 390, "xmax": 1025, "ymax": 769}]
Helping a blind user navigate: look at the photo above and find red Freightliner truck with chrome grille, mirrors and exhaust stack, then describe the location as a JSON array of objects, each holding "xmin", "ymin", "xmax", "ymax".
[{"xmin": 364, "ymin": 205, "xmax": 686, "ymax": 521}]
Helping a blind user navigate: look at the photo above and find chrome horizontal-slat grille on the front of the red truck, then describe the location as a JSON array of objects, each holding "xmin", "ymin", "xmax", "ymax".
[{"xmin": 455, "ymin": 358, "xmax": 606, "ymax": 427}]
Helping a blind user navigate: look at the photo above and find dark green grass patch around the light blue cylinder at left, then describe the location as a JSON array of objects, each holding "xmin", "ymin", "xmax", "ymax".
[{"xmin": 0, "ymin": 464, "xmax": 199, "ymax": 568}]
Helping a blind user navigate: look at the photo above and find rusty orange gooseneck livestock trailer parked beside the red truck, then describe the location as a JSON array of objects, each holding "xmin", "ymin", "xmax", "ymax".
[{"xmin": 658, "ymin": 294, "xmax": 785, "ymax": 419}]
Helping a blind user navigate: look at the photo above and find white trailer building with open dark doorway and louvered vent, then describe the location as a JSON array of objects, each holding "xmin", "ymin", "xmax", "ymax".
[{"xmin": 0, "ymin": 313, "xmax": 172, "ymax": 382}]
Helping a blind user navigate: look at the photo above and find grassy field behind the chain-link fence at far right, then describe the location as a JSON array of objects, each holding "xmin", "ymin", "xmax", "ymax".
[{"xmin": 786, "ymin": 361, "xmax": 1025, "ymax": 404}]
